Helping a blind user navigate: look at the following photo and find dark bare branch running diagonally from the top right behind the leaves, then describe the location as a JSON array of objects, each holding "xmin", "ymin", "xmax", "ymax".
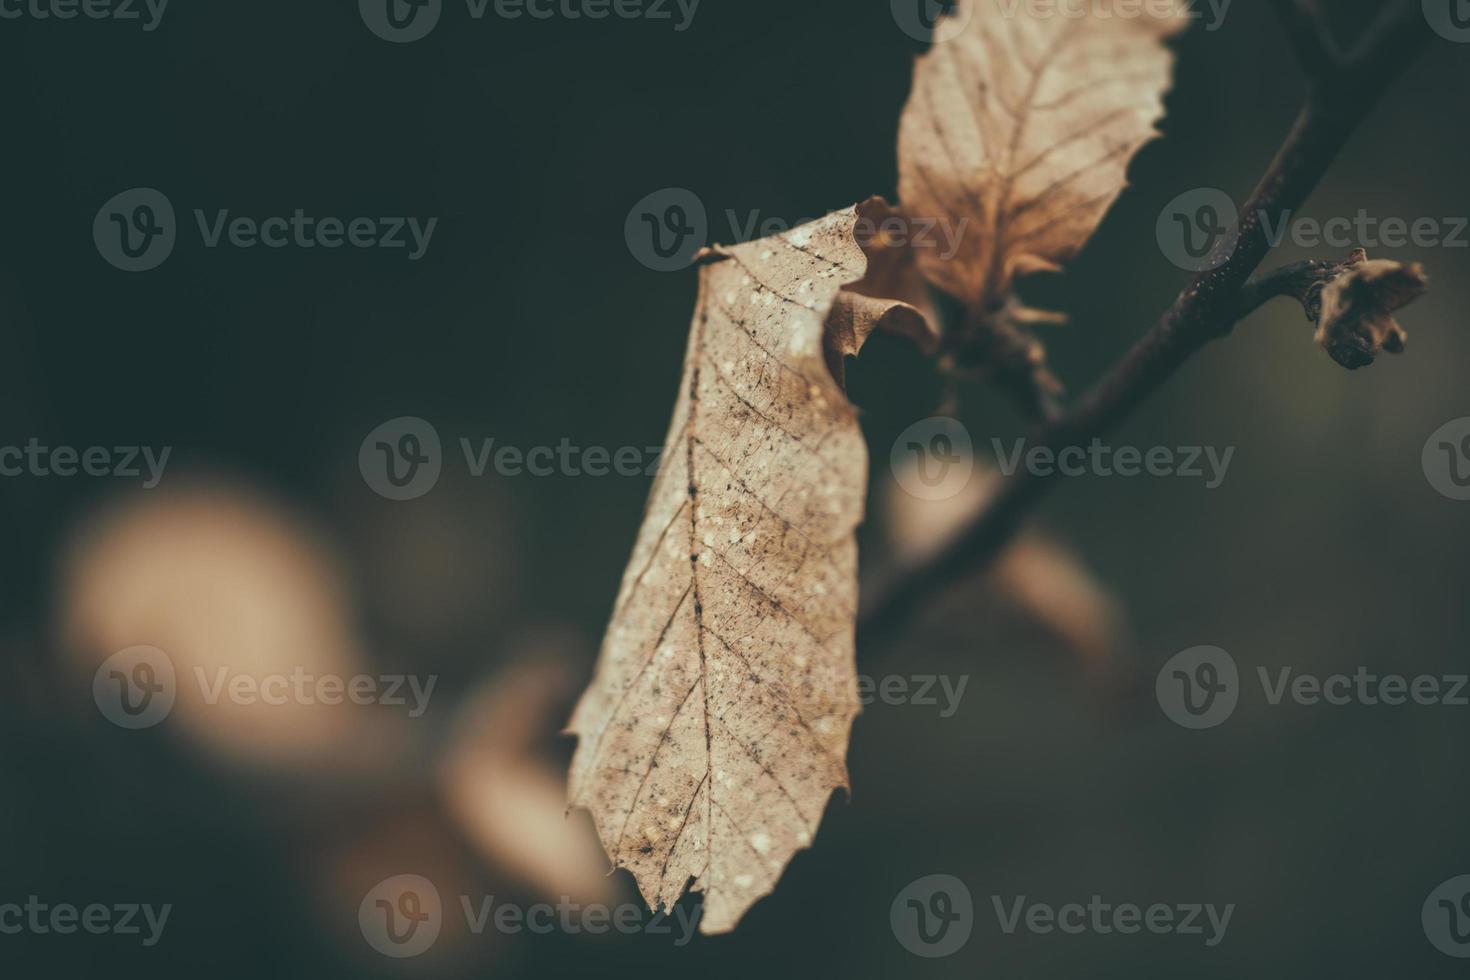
[{"xmin": 857, "ymin": 7, "xmax": 1427, "ymax": 646}]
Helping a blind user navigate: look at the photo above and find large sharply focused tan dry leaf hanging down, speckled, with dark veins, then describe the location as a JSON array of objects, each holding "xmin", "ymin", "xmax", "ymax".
[{"xmin": 569, "ymin": 207, "xmax": 911, "ymax": 933}]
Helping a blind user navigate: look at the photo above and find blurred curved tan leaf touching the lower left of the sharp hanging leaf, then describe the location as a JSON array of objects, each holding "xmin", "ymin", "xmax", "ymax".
[{"xmin": 438, "ymin": 646, "xmax": 617, "ymax": 905}]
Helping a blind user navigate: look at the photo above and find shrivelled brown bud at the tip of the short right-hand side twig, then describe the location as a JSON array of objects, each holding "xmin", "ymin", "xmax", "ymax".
[{"xmin": 1308, "ymin": 248, "xmax": 1429, "ymax": 370}]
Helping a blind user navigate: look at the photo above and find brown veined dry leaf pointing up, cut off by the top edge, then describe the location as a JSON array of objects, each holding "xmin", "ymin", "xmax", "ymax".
[{"xmin": 898, "ymin": 0, "xmax": 1188, "ymax": 309}]
